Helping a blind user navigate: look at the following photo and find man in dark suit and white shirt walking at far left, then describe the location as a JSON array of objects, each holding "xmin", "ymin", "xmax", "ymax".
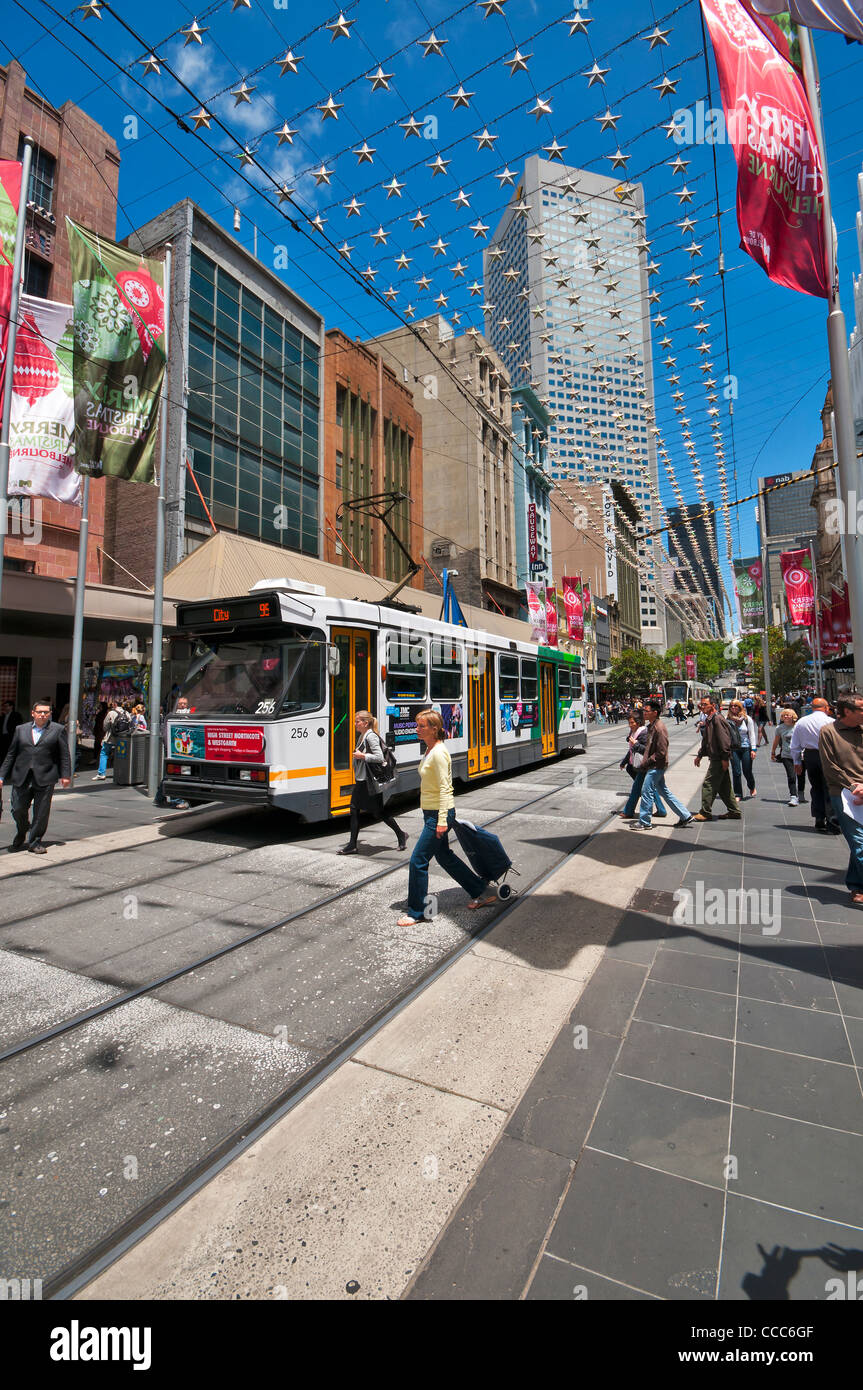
[{"xmin": 0, "ymin": 699, "xmax": 72, "ymax": 855}]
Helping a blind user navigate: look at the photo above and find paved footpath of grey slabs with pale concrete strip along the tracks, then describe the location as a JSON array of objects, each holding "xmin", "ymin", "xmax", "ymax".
[{"xmin": 78, "ymin": 751, "xmax": 863, "ymax": 1300}]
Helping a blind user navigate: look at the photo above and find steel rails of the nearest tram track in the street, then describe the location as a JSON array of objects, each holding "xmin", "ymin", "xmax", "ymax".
[{"xmin": 0, "ymin": 739, "xmax": 639, "ymax": 1300}]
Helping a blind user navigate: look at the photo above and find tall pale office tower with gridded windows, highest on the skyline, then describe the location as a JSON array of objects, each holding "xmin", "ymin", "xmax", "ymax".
[{"xmin": 484, "ymin": 156, "xmax": 666, "ymax": 651}]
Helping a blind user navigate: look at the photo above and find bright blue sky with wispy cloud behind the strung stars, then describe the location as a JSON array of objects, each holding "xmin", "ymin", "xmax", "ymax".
[{"xmin": 6, "ymin": 0, "xmax": 863, "ymax": 625}]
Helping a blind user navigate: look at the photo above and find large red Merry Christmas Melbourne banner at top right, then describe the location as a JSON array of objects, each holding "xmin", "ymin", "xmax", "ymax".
[{"xmin": 702, "ymin": 0, "xmax": 830, "ymax": 299}]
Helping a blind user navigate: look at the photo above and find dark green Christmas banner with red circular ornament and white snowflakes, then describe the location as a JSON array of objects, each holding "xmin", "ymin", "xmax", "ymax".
[{"xmin": 65, "ymin": 217, "xmax": 165, "ymax": 482}]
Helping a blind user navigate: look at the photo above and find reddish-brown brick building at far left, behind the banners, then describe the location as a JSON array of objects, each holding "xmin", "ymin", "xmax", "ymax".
[{"xmin": 0, "ymin": 60, "xmax": 126, "ymax": 708}]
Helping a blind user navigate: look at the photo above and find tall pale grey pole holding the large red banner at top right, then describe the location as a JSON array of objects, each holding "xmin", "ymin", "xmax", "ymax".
[{"xmin": 798, "ymin": 25, "xmax": 863, "ymax": 676}]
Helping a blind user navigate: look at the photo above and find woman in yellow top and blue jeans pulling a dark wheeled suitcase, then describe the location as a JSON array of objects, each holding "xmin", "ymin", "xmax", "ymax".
[{"xmin": 397, "ymin": 709, "xmax": 496, "ymax": 927}]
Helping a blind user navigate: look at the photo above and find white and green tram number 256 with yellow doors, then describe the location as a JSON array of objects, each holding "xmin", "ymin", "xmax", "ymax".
[{"xmin": 164, "ymin": 580, "xmax": 586, "ymax": 821}]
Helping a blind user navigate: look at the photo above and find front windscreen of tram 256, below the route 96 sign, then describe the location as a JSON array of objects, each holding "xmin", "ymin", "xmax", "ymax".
[{"xmin": 181, "ymin": 632, "xmax": 327, "ymax": 719}]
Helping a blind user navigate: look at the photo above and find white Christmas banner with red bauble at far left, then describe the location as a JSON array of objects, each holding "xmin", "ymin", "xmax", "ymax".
[{"xmin": 0, "ymin": 295, "xmax": 82, "ymax": 506}]
